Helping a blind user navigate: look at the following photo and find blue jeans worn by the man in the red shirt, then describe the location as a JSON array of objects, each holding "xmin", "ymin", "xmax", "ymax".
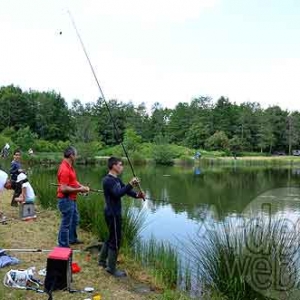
[{"xmin": 57, "ymin": 198, "xmax": 79, "ymax": 247}]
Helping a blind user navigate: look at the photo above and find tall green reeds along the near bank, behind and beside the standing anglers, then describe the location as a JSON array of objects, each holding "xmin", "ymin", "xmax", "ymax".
[{"xmin": 31, "ymin": 170, "xmax": 190, "ymax": 299}]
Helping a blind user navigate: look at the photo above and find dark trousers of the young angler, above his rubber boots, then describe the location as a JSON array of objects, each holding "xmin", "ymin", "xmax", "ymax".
[{"xmin": 105, "ymin": 214, "xmax": 122, "ymax": 251}]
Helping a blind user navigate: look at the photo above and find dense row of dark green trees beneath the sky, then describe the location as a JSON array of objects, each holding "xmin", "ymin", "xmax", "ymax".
[{"xmin": 0, "ymin": 85, "xmax": 300, "ymax": 153}]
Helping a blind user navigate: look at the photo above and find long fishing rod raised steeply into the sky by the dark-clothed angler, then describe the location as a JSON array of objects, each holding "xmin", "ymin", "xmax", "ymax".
[{"xmin": 68, "ymin": 10, "xmax": 145, "ymax": 201}]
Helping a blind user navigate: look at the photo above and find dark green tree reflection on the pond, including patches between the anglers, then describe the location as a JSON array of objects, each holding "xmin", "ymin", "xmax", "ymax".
[{"xmin": 29, "ymin": 166, "xmax": 299, "ymax": 224}]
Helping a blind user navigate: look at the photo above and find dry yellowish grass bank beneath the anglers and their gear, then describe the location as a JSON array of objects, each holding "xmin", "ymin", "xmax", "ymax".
[{"xmin": 0, "ymin": 192, "xmax": 189, "ymax": 300}]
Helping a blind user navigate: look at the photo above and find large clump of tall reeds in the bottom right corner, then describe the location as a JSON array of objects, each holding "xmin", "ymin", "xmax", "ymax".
[{"xmin": 189, "ymin": 217, "xmax": 300, "ymax": 300}]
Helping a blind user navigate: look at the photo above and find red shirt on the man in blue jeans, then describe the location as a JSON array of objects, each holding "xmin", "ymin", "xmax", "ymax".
[{"xmin": 57, "ymin": 159, "xmax": 80, "ymax": 201}]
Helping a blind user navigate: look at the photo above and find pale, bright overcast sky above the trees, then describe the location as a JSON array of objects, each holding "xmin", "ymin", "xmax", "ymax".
[{"xmin": 0, "ymin": 0, "xmax": 300, "ymax": 110}]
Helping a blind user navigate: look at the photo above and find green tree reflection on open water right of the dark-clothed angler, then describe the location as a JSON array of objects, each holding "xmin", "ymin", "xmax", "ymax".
[{"xmin": 133, "ymin": 167, "xmax": 297, "ymax": 220}]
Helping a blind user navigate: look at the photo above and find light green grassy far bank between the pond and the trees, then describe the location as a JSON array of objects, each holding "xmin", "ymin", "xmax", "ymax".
[{"xmin": 15, "ymin": 146, "xmax": 300, "ymax": 166}]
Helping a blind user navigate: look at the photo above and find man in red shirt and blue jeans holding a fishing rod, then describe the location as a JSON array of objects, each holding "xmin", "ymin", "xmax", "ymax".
[{"xmin": 57, "ymin": 147, "xmax": 90, "ymax": 247}]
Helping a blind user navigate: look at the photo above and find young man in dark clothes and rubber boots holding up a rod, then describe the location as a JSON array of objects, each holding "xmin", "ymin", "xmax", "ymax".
[{"xmin": 99, "ymin": 157, "xmax": 145, "ymax": 277}]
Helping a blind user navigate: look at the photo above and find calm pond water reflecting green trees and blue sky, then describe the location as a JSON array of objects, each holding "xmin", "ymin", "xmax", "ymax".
[{"xmin": 21, "ymin": 165, "xmax": 300, "ymax": 245}]
